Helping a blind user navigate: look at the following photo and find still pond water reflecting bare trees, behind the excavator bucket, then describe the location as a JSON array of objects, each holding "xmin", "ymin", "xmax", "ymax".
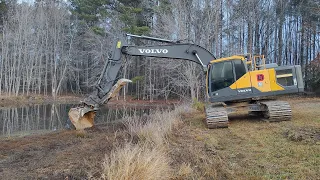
[{"xmin": 0, "ymin": 104, "xmax": 167, "ymax": 137}]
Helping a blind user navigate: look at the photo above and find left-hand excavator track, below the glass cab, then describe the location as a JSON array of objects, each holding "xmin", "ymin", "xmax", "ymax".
[{"xmin": 205, "ymin": 106, "xmax": 229, "ymax": 129}]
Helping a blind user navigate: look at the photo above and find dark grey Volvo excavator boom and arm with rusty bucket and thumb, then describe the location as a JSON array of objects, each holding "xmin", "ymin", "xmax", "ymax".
[{"xmin": 69, "ymin": 34, "xmax": 215, "ymax": 130}]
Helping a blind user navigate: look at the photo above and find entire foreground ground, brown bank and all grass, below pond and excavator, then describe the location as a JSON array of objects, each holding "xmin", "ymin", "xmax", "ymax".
[{"xmin": 0, "ymin": 98, "xmax": 320, "ymax": 179}]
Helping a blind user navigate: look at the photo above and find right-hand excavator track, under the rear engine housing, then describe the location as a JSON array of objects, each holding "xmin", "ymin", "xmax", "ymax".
[{"xmin": 261, "ymin": 101, "xmax": 292, "ymax": 122}]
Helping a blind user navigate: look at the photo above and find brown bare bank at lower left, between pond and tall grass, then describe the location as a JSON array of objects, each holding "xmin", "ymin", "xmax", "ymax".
[{"xmin": 0, "ymin": 125, "xmax": 128, "ymax": 179}]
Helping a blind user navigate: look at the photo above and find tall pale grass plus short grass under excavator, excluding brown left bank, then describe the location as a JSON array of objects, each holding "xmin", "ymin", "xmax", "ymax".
[{"xmin": 97, "ymin": 99, "xmax": 320, "ymax": 179}]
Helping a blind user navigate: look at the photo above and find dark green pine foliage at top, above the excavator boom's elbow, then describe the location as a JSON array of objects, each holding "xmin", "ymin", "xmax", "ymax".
[{"xmin": 70, "ymin": 0, "xmax": 150, "ymax": 35}]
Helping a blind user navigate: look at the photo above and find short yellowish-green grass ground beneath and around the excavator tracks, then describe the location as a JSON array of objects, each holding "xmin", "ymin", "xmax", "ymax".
[{"xmin": 173, "ymin": 99, "xmax": 320, "ymax": 179}]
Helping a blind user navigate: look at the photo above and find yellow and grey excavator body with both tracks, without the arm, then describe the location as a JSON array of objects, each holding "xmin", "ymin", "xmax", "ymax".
[{"xmin": 206, "ymin": 55, "xmax": 304, "ymax": 128}]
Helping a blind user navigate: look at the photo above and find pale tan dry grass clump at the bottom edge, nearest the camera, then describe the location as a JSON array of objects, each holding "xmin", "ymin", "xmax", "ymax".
[{"xmin": 102, "ymin": 144, "xmax": 171, "ymax": 180}]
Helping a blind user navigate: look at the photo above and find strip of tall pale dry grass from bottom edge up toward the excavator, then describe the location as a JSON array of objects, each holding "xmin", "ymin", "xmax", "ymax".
[{"xmin": 102, "ymin": 106, "xmax": 191, "ymax": 180}]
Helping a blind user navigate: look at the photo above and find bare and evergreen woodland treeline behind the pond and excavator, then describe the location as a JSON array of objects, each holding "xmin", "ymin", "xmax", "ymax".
[{"xmin": 0, "ymin": 0, "xmax": 320, "ymax": 100}]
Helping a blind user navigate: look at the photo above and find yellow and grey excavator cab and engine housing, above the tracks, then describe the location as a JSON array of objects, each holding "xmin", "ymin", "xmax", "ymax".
[{"xmin": 207, "ymin": 55, "xmax": 303, "ymax": 102}]
